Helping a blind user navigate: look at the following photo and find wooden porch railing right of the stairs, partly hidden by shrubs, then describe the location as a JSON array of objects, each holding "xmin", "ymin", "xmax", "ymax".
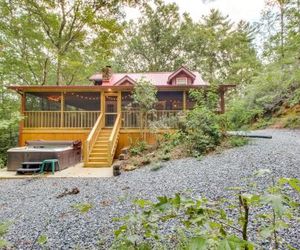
[{"xmin": 122, "ymin": 110, "xmax": 183, "ymax": 128}]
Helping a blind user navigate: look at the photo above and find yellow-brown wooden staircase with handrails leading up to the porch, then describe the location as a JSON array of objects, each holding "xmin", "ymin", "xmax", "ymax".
[{"xmin": 84, "ymin": 115, "xmax": 121, "ymax": 167}]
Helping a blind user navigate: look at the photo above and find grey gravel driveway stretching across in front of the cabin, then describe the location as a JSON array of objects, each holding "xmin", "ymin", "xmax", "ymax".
[{"xmin": 0, "ymin": 130, "xmax": 300, "ymax": 249}]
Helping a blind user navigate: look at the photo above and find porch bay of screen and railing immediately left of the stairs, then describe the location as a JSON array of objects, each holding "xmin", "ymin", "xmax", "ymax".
[{"xmin": 63, "ymin": 92, "xmax": 101, "ymax": 128}]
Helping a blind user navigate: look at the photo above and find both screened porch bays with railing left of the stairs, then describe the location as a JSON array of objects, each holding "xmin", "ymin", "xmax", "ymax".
[{"xmin": 24, "ymin": 92, "xmax": 100, "ymax": 128}]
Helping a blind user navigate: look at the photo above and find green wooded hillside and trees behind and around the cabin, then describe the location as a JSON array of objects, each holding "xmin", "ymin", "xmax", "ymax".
[{"xmin": 0, "ymin": 0, "xmax": 300, "ymax": 166}]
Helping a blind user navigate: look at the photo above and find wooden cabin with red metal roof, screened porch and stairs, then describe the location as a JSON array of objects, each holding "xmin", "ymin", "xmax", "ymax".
[{"xmin": 9, "ymin": 66, "xmax": 234, "ymax": 167}]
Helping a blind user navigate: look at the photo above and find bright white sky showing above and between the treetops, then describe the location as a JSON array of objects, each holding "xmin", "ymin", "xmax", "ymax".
[{"xmin": 126, "ymin": 0, "xmax": 265, "ymax": 22}]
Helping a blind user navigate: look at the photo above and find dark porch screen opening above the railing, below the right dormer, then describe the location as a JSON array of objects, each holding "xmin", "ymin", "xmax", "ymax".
[{"xmin": 156, "ymin": 91, "xmax": 183, "ymax": 110}]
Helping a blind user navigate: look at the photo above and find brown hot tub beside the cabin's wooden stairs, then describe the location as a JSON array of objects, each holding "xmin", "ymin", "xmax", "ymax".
[{"xmin": 7, "ymin": 141, "xmax": 81, "ymax": 171}]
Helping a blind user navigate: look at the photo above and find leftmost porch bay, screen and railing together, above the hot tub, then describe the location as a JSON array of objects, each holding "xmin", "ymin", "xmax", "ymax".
[{"xmin": 24, "ymin": 92, "xmax": 61, "ymax": 128}]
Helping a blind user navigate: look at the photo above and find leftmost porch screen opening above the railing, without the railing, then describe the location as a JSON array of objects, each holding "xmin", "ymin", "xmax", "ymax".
[{"xmin": 25, "ymin": 92, "xmax": 61, "ymax": 111}]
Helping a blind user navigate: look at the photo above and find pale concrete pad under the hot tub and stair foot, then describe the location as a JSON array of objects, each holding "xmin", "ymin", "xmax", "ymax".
[{"xmin": 0, "ymin": 163, "xmax": 113, "ymax": 179}]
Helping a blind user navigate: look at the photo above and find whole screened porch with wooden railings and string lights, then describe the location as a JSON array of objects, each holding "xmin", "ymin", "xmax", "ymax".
[{"xmin": 23, "ymin": 91, "xmax": 194, "ymax": 129}]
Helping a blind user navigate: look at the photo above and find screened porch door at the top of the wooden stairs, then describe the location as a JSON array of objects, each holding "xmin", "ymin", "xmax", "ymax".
[{"xmin": 104, "ymin": 94, "xmax": 118, "ymax": 127}]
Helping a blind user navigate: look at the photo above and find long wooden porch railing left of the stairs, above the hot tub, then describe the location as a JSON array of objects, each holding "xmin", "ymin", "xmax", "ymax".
[{"xmin": 24, "ymin": 111, "xmax": 100, "ymax": 128}]
